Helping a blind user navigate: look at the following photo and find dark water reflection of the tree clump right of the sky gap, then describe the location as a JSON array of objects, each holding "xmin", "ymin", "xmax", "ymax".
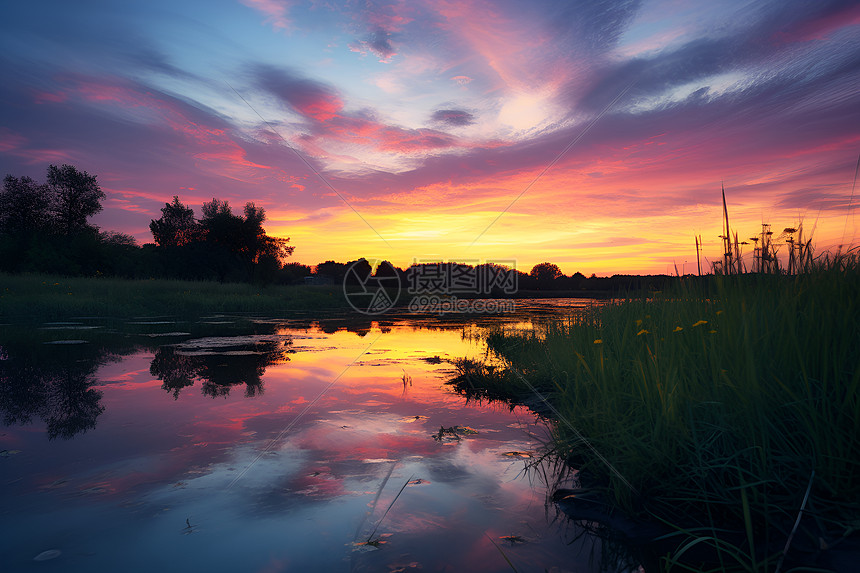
[{"xmin": 149, "ymin": 338, "xmax": 292, "ymax": 398}]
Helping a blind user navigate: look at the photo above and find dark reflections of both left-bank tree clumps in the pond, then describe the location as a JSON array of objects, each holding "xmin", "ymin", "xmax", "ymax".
[{"xmin": 0, "ymin": 322, "xmax": 292, "ymax": 439}]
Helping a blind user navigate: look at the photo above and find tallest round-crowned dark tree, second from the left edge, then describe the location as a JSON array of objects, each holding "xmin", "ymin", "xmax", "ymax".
[{"xmin": 48, "ymin": 164, "xmax": 105, "ymax": 237}]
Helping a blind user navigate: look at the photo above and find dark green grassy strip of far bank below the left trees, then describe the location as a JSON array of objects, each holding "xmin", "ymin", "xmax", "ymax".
[{"xmin": 0, "ymin": 274, "xmax": 349, "ymax": 322}]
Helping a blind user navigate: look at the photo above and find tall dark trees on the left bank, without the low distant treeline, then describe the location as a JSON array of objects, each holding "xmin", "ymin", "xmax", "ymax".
[{"xmin": 0, "ymin": 165, "xmax": 294, "ymax": 282}]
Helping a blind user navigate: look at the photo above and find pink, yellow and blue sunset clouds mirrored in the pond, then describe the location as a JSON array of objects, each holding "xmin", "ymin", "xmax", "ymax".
[{"xmin": 0, "ymin": 321, "xmax": 592, "ymax": 571}]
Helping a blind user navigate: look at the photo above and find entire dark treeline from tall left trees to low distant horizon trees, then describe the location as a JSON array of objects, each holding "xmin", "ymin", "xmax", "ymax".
[{"xmin": 0, "ymin": 165, "xmax": 671, "ymax": 290}]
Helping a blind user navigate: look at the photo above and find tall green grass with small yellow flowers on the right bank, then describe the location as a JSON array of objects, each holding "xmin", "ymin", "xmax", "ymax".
[{"xmin": 454, "ymin": 255, "xmax": 860, "ymax": 571}]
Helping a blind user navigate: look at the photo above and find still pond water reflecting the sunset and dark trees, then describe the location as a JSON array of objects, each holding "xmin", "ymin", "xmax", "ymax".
[{"xmin": 0, "ymin": 302, "xmax": 613, "ymax": 573}]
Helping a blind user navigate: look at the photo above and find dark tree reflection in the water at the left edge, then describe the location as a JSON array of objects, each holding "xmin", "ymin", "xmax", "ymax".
[{"xmin": 0, "ymin": 344, "xmax": 104, "ymax": 440}]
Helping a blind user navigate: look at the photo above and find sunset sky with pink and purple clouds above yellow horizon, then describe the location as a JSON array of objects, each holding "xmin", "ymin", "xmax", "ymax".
[{"xmin": 0, "ymin": 0, "xmax": 860, "ymax": 275}]
